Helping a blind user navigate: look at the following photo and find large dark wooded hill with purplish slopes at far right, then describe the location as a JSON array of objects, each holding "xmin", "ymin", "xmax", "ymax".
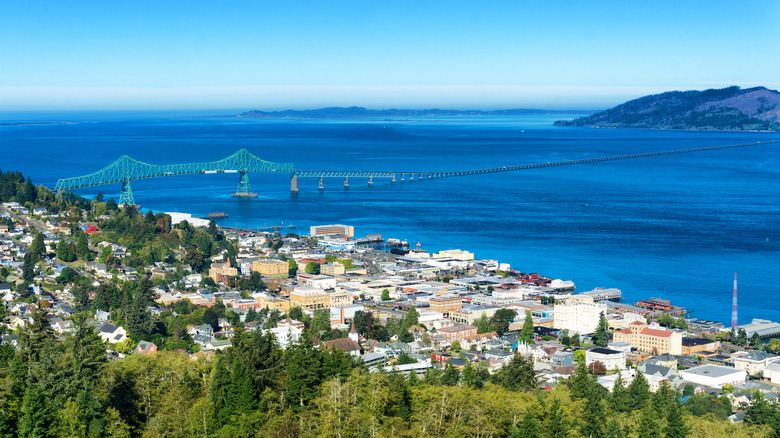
[{"xmin": 555, "ymin": 86, "xmax": 780, "ymax": 131}]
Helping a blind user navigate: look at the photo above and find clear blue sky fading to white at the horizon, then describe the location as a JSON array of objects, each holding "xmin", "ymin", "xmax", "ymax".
[{"xmin": 0, "ymin": 0, "xmax": 780, "ymax": 111}]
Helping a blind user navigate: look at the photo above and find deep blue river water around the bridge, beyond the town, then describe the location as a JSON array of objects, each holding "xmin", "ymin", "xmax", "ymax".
[{"xmin": 0, "ymin": 113, "xmax": 780, "ymax": 322}]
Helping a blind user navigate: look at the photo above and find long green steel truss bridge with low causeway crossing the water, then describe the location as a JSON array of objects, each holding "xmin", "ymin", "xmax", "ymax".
[{"xmin": 55, "ymin": 140, "xmax": 780, "ymax": 204}]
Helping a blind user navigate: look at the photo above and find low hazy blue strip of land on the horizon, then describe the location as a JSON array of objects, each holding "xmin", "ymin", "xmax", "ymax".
[{"xmin": 238, "ymin": 106, "xmax": 582, "ymax": 119}]
